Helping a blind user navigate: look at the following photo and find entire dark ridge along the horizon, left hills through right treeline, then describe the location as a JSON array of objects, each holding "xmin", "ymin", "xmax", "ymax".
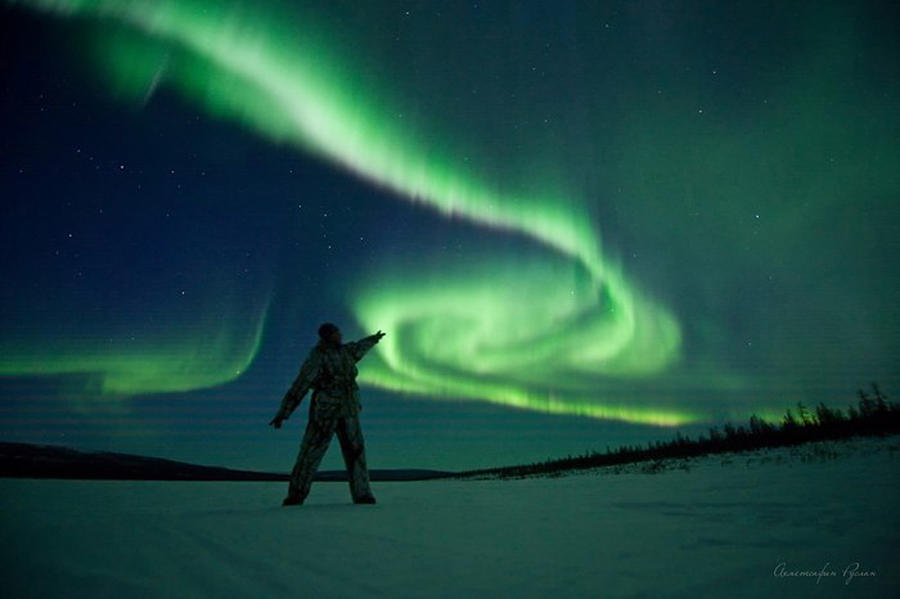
[{"xmin": 0, "ymin": 383, "xmax": 900, "ymax": 482}]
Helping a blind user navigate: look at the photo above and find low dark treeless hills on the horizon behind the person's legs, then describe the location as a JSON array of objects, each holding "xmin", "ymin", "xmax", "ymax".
[{"xmin": 0, "ymin": 442, "xmax": 453, "ymax": 482}]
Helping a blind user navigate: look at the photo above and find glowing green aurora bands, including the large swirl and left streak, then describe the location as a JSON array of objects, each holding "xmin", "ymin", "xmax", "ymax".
[{"xmin": 7, "ymin": 0, "xmax": 701, "ymax": 426}]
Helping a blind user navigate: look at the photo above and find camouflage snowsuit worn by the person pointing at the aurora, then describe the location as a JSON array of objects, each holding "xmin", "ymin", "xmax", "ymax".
[{"xmin": 278, "ymin": 334, "xmax": 379, "ymax": 501}]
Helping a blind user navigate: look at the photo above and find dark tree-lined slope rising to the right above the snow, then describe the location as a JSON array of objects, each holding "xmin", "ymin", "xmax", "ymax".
[{"xmin": 451, "ymin": 383, "xmax": 900, "ymax": 479}]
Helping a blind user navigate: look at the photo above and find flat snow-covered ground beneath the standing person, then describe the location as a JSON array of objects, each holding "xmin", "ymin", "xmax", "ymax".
[{"xmin": 0, "ymin": 436, "xmax": 900, "ymax": 599}]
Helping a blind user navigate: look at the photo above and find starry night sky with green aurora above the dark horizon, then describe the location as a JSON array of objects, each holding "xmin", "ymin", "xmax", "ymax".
[{"xmin": 0, "ymin": 0, "xmax": 900, "ymax": 471}]
